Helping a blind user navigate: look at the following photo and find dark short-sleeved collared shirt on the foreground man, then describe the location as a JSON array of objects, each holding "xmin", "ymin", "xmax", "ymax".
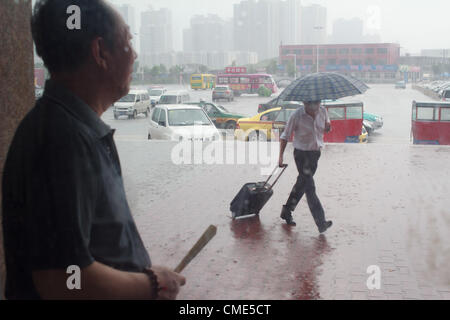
[{"xmin": 2, "ymin": 80, "xmax": 151, "ymax": 299}]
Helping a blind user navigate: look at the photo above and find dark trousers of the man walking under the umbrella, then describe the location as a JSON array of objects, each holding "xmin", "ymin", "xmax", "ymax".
[{"xmin": 286, "ymin": 149, "xmax": 325, "ymax": 227}]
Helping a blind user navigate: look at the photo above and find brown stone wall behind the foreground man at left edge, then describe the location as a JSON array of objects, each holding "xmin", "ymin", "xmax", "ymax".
[{"xmin": 0, "ymin": 0, "xmax": 34, "ymax": 299}]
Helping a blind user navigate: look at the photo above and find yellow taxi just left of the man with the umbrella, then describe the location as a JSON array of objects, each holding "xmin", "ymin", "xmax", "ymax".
[{"xmin": 235, "ymin": 107, "xmax": 297, "ymax": 141}]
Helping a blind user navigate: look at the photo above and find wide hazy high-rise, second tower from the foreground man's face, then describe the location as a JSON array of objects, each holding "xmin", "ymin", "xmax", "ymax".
[{"xmin": 140, "ymin": 8, "xmax": 173, "ymax": 65}]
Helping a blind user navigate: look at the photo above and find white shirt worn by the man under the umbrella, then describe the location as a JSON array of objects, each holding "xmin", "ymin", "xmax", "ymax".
[{"xmin": 280, "ymin": 106, "xmax": 330, "ymax": 151}]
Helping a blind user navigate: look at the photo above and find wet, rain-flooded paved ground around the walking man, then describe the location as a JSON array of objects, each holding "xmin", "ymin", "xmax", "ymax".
[{"xmin": 103, "ymin": 85, "xmax": 450, "ymax": 299}]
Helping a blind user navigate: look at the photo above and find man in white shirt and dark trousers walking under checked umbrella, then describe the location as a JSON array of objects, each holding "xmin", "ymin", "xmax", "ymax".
[{"xmin": 279, "ymin": 101, "xmax": 332, "ymax": 233}]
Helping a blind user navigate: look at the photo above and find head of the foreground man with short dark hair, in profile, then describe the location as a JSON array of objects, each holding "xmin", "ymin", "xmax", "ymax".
[{"xmin": 31, "ymin": 0, "xmax": 136, "ymax": 99}]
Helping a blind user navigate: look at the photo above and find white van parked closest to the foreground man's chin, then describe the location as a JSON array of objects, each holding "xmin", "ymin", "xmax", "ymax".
[{"xmin": 113, "ymin": 90, "xmax": 151, "ymax": 119}]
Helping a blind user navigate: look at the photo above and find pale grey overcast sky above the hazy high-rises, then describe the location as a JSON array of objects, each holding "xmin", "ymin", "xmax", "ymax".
[{"xmin": 37, "ymin": 0, "xmax": 450, "ymax": 53}]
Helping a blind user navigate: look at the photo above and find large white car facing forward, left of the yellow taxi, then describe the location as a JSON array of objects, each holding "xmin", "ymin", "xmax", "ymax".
[{"xmin": 148, "ymin": 104, "xmax": 220, "ymax": 141}]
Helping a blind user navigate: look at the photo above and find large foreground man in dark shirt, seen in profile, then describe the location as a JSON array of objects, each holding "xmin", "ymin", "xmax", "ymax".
[{"xmin": 2, "ymin": 0, "xmax": 185, "ymax": 299}]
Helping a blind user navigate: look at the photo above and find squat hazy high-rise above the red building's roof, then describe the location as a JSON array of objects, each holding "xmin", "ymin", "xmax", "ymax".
[{"xmin": 331, "ymin": 18, "xmax": 364, "ymax": 43}]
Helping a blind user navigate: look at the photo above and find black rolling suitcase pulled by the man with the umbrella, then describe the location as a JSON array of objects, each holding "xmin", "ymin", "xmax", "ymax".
[{"xmin": 230, "ymin": 164, "xmax": 287, "ymax": 219}]
